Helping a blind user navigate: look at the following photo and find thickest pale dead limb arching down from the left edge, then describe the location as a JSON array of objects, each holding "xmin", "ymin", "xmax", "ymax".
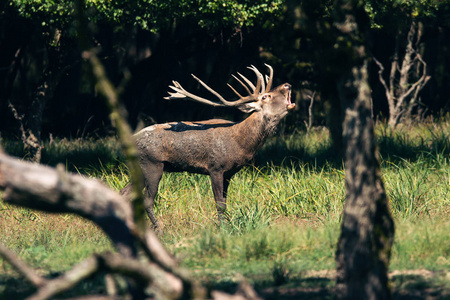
[{"xmin": 0, "ymin": 153, "xmax": 136, "ymax": 257}]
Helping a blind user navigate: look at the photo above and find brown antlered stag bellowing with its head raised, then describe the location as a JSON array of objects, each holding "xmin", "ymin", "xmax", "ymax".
[{"xmin": 120, "ymin": 64, "xmax": 295, "ymax": 229}]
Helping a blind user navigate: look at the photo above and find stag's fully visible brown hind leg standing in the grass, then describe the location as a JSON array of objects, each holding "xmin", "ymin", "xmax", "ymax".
[{"xmin": 141, "ymin": 162, "xmax": 164, "ymax": 228}]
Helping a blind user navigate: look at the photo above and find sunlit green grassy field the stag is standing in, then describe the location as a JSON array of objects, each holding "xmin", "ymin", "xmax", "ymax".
[{"xmin": 0, "ymin": 121, "xmax": 450, "ymax": 299}]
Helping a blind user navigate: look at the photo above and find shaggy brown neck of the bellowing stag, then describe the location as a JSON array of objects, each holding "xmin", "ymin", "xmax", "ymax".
[{"xmin": 234, "ymin": 112, "xmax": 280, "ymax": 153}]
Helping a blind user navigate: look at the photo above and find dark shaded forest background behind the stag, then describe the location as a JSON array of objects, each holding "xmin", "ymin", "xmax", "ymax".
[{"xmin": 0, "ymin": 0, "xmax": 450, "ymax": 151}]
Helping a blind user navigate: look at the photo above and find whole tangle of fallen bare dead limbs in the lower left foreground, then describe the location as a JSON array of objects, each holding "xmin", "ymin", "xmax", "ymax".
[{"xmin": 0, "ymin": 152, "xmax": 259, "ymax": 300}]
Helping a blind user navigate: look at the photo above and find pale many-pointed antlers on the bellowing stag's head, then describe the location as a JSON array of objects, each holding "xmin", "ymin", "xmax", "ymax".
[{"xmin": 164, "ymin": 64, "xmax": 273, "ymax": 107}]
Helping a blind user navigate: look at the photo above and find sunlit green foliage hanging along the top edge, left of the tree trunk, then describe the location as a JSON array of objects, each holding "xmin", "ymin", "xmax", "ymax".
[{"xmin": 11, "ymin": 0, "xmax": 284, "ymax": 32}]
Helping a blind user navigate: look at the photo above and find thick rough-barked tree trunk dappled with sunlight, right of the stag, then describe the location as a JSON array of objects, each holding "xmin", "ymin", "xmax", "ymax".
[{"xmin": 334, "ymin": 0, "xmax": 394, "ymax": 299}]
